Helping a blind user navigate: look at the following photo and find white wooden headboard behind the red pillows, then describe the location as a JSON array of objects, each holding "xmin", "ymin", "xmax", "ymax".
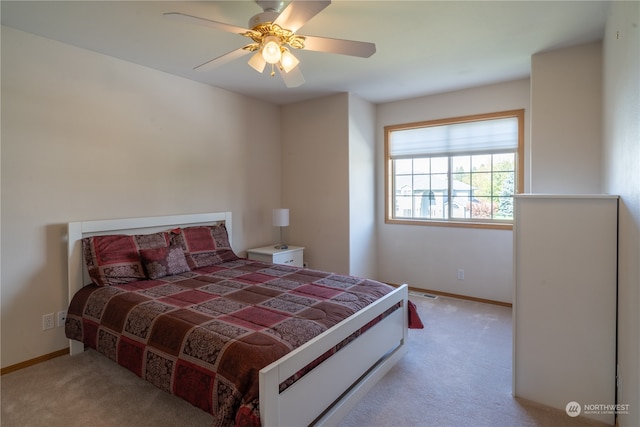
[{"xmin": 67, "ymin": 212, "xmax": 233, "ymax": 302}]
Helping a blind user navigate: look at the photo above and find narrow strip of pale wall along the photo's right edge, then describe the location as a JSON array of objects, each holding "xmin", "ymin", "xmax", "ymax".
[{"xmin": 603, "ymin": 2, "xmax": 640, "ymax": 427}]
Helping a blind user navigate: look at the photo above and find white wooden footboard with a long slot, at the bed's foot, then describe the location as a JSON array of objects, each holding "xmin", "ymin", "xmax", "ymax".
[{"xmin": 260, "ymin": 285, "xmax": 409, "ymax": 427}]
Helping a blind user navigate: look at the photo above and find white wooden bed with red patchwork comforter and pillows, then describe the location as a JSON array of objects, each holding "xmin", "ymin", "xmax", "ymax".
[{"xmin": 65, "ymin": 212, "xmax": 409, "ymax": 426}]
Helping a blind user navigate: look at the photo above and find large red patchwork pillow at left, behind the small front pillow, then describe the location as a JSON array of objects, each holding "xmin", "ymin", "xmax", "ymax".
[{"xmin": 82, "ymin": 232, "xmax": 169, "ymax": 286}]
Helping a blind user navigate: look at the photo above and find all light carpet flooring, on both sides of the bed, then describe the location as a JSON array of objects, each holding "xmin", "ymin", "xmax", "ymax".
[{"xmin": 0, "ymin": 296, "xmax": 603, "ymax": 427}]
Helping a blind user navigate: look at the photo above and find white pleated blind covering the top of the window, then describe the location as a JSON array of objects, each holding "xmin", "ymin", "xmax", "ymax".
[{"xmin": 389, "ymin": 117, "xmax": 518, "ymax": 158}]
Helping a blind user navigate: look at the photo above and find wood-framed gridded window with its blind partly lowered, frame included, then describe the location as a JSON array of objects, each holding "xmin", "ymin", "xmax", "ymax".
[{"xmin": 385, "ymin": 110, "xmax": 524, "ymax": 228}]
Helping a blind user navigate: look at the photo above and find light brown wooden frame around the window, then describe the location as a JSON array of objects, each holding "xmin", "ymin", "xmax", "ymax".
[{"xmin": 384, "ymin": 109, "xmax": 525, "ymax": 230}]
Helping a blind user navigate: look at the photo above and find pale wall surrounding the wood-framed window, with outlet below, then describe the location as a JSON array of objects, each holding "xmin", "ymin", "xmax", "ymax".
[{"xmin": 376, "ymin": 79, "xmax": 529, "ymax": 303}]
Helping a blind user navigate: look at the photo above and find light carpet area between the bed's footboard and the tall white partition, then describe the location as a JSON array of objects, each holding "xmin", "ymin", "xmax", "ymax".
[{"xmin": 340, "ymin": 295, "xmax": 605, "ymax": 427}]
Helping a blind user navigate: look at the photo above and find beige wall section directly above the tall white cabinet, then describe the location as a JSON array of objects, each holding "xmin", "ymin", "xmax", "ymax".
[{"xmin": 530, "ymin": 43, "xmax": 602, "ymax": 194}]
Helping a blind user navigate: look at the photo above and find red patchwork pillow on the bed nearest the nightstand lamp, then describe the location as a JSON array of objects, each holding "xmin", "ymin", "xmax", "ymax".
[{"xmin": 171, "ymin": 224, "xmax": 238, "ymax": 270}]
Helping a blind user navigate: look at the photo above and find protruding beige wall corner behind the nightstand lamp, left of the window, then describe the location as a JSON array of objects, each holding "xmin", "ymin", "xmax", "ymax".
[{"xmin": 282, "ymin": 93, "xmax": 377, "ymax": 278}]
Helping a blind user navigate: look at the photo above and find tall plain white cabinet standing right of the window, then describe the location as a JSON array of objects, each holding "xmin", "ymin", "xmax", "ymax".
[{"xmin": 513, "ymin": 194, "xmax": 618, "ymax": 424}]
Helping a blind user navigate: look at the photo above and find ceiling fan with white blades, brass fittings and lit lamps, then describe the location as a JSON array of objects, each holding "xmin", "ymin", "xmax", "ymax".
[{"xmin": 164, "ymin": 0, "xmax": 376, "ymax": 87}]
